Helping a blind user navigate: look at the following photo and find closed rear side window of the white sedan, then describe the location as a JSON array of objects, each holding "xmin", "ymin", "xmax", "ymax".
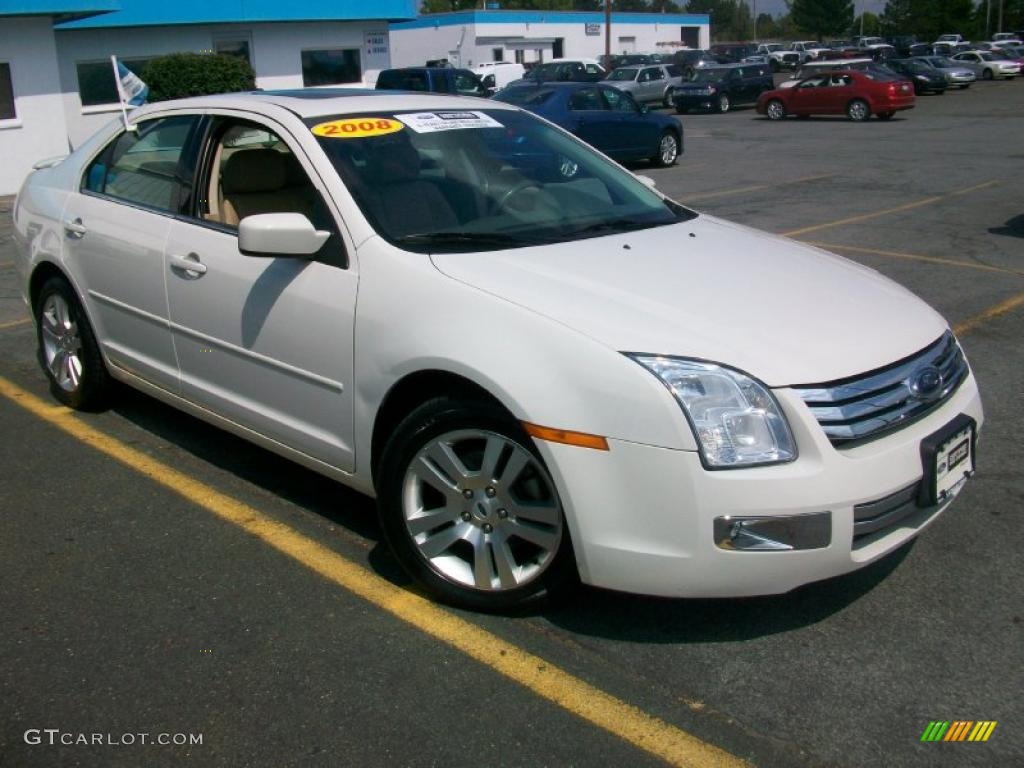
[{"xmin": 82, "ymin": 112, "xmax": 197, "ymax": 213}]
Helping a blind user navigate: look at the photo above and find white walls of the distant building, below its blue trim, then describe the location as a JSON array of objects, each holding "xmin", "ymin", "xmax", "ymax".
[{"xmin": 391, "ymin": 22, "xmax": 711, "ymax": 68}]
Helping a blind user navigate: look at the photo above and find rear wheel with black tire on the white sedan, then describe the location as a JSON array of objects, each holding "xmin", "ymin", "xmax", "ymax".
[{"xmin": 34, "ymin": 276, "xmax": 114, "ymax": 411}]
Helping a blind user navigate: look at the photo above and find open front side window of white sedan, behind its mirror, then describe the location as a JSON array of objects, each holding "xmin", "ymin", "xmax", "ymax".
[{"xmin": 198, "ymin": 119, "xmax": 345, "ymax": 266}]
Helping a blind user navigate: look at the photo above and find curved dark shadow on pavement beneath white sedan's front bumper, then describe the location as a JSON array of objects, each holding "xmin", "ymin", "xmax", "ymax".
[{"xmin": 541, "ymin": 540, "xmax": 916, "ymax": 643}]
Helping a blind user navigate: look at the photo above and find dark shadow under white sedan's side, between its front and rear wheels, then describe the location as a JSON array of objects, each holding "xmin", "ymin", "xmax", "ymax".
[{"xmin": 113, "ymin": 387, "xmax": 380, "ymax": 542}]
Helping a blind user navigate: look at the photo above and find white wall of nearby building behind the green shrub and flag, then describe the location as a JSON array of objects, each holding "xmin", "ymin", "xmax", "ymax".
[{"xmin": 56, "ymin": 22, "xmax": 391, "ymax": 146}]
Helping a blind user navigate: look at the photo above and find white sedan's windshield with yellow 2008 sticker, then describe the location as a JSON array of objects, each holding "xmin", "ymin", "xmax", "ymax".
[{"xmin": 305, "ymin": 110, "xmax": 696, "ymax": 253}]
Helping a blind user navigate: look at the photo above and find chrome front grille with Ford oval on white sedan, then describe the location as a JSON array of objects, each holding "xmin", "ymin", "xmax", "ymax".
[{"xmin": 794, "ymin": 331, "xmax": 968, "ymax": 447}]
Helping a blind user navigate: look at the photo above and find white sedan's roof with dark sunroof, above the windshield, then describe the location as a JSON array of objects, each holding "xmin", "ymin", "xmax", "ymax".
[{"xmin": 133, "ymin": 88, "xmax": 515, "ymax": 118}]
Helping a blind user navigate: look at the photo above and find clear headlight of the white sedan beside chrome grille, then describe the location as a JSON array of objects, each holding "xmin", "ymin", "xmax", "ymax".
[{"xmin": 630, "ymin": 355, "xmax": 797, "ymax": 469}]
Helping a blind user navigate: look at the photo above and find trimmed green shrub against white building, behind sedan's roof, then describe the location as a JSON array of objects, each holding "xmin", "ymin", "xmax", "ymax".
[{"xmin": 140, "ymin": 53, "xmax": 256, "ymax": 101}]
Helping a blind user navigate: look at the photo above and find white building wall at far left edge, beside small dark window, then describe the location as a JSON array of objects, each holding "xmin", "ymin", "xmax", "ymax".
[{"xmin": 0, "ymin": 16, "xmax": 68, "ymax": 195}]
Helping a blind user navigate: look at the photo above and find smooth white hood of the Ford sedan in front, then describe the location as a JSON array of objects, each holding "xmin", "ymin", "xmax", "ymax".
[{"xmin": 431, "ymin": 216, "xmax": 946, "ymax": 387}]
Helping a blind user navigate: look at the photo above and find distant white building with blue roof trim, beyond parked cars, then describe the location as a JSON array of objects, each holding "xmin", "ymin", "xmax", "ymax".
[{"xmin": 391, "ymin": 10, "xmax": 711, "ymax": 68}]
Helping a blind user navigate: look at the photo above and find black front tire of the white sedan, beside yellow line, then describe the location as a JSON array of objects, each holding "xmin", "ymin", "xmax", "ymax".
[{"xmin": 375, "ymin": 395, "xmax": 579, "ymax": 611}]
